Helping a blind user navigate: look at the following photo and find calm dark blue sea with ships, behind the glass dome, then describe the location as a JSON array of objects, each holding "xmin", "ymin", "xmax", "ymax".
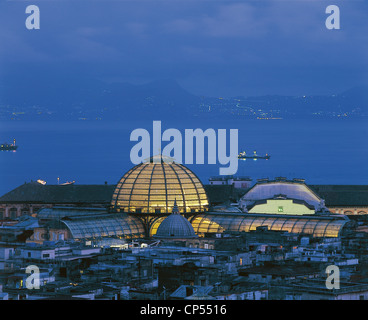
[{"xmin": 0, "ymin": 118, "xmax": 368, "ymax": 195}]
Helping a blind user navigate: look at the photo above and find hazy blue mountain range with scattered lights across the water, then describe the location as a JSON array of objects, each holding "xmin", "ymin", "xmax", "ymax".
[{"xmin": 0, "ymin": 72, "xmax": 368, "ymax": 120}]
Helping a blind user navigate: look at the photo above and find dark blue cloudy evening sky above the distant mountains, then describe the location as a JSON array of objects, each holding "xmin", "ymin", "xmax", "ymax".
[{"xmin": 0, "ymin": 0, "xmax": 368, "ymax": 97}]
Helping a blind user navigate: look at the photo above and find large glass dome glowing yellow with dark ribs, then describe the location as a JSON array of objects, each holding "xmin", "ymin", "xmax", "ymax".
[{"xmin": 111, "ymin": 155, "xmax": 208, "ymax": 214}]
